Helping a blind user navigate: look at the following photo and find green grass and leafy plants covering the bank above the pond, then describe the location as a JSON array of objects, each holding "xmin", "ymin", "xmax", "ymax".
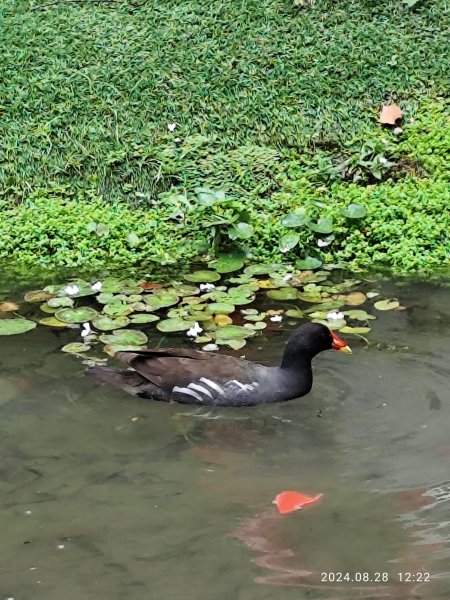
[{"xmin": 0, "ymin": 0, "xmax": 450, "ymax": 273}]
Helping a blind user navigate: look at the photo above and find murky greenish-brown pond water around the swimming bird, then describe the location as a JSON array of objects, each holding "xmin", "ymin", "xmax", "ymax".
[{"xmin": 0, "ymin": 280, "xmax": 450, "ymax": 600}]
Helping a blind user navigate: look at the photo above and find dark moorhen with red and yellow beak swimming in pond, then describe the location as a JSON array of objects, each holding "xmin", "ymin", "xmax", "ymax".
[{"xmin": 86, "ymin": 323, "xmax": 351, "ymax": 406}]
